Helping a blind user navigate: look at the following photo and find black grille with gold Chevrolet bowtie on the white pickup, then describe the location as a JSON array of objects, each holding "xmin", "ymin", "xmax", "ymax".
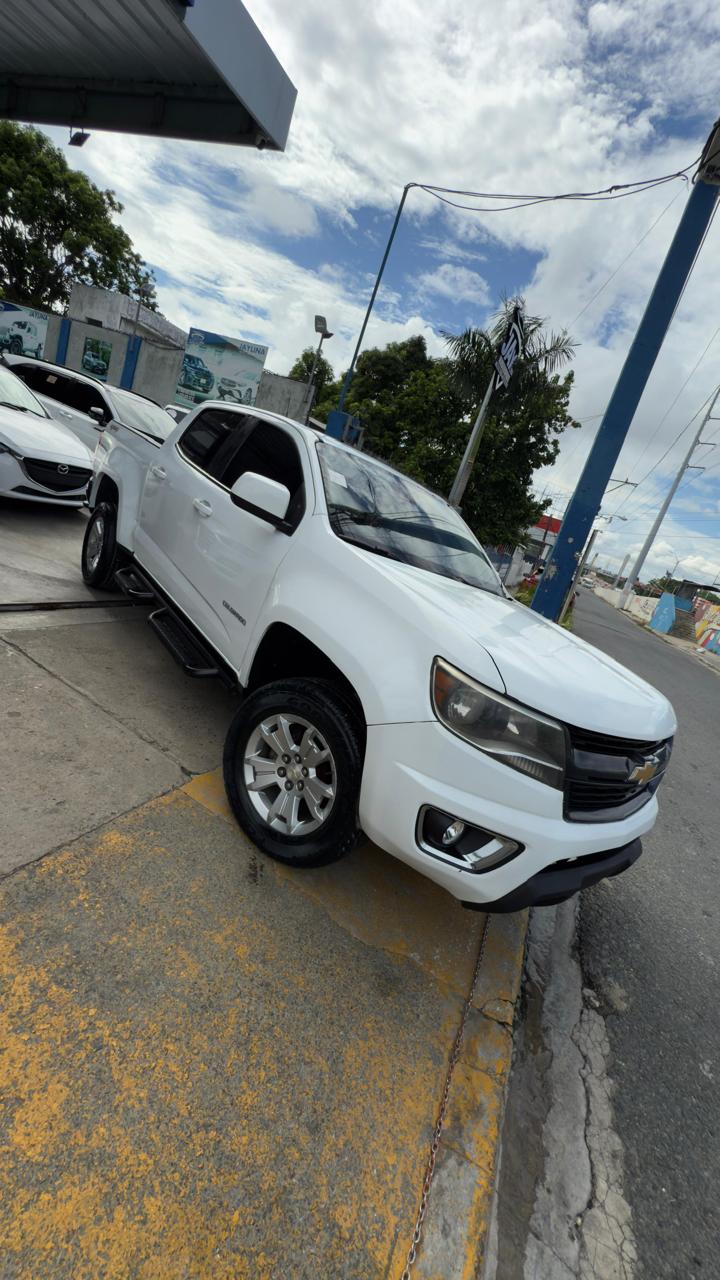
[{"xmin": 565, "ymin": 726, "xmax": 673, "ymax": 822}]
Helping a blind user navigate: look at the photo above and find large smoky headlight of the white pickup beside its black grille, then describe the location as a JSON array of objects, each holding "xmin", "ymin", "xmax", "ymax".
[{"xmin": 432, "ymin": 658, "xmax": 565, "ymax": 791}]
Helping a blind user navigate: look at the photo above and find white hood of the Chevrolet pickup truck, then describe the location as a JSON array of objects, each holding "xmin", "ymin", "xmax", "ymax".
[{"xmin": 364, "ymin": 553, "xmax": 676, "ymax": 742}]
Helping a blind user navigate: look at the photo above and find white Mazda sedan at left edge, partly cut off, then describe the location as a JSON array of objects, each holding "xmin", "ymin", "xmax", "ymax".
[{"xmin": 0, "ymin": 365, "xmax": 92, "ymax": 507}]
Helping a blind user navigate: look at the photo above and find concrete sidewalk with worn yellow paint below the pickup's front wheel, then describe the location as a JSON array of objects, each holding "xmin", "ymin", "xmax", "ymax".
[{"xmin": 0, "ymin": 773, "xmax": 525, "ymax": 1280}]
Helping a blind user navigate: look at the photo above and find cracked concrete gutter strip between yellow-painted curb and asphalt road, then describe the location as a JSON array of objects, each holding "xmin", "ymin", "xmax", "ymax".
[{"xmin": 486, "ymin": 901, "xmax": 637, "ymax": 1280}]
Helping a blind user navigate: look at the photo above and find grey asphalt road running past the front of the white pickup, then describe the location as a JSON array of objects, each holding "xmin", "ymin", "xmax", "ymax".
[{"xmin": 575, "ymin": 591, "xmax": 720, "ymax": 1280}]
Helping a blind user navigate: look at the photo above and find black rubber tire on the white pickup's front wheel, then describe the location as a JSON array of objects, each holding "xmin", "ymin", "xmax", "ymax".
[{"xmin": 223, "ymin": 677, "xmax": 363, "ymax": 867}]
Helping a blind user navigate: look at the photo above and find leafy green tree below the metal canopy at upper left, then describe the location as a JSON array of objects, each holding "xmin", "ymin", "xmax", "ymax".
[{"xmin": 0, "ymin": 120, "xmax": 156, "ymax": 310}]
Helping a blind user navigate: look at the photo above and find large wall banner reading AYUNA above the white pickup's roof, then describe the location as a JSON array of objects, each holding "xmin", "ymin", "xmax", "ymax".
[{"xmin": 176, "ymin": 329, "xmax": 268, "ymax": 404}]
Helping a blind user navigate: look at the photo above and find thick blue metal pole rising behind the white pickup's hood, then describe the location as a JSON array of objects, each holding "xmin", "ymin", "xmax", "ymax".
[{"xmin": 532, "ymin": 179, "xmax": 720, "ymax": 620}]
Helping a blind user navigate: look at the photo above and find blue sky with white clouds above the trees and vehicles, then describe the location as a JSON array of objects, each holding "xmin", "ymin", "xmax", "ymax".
[{"xmin": 49, "ymin": 0, "xmax": 720, "ymax": 581}]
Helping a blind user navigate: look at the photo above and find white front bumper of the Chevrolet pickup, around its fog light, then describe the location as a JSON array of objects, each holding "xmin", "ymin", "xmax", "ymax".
[{"xmin": 360, "ymin": 721, "xmax": 657, "ymax": 911}]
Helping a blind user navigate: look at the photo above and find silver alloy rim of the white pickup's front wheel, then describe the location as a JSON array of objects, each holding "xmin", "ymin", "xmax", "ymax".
[{"xmin": 242, "ymin": 712, "xmax": 337, "ymax": 840}]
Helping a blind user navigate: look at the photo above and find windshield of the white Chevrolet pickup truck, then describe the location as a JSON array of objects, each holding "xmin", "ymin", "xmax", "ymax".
[{"xmin": 318, "ymin": 440, "xmax": 505, "ymax": 595}]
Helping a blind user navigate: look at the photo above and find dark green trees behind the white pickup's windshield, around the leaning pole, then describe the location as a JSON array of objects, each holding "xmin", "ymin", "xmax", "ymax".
[{"xmin": 346, "ymin": 312, "xmax": 578, "ymax": 545}]
